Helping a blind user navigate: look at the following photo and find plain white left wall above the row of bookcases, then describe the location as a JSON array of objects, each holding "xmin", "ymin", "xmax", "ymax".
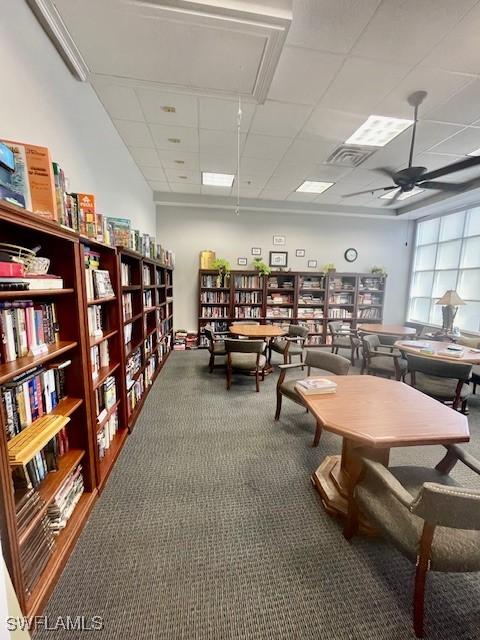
[{"xmin": 0, "ymin": 0, "xmax": 155, "ymax": 234}]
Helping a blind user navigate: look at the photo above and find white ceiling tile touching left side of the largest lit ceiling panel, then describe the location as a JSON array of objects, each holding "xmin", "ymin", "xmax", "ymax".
[{"xmin": 300, "ymin": 107, "xmax": 369, "ymax": 146}]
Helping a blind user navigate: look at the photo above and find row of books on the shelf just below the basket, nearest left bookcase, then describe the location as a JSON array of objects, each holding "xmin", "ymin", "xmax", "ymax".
[{"xmin": 0, "ymin": 300, "xmax": 58, "ymax": 362}]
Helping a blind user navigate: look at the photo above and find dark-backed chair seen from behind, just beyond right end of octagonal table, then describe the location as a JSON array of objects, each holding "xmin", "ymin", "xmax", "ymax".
[{"xmin": 407, "ymin": 353, "xmax": 472, "ymax": 413}]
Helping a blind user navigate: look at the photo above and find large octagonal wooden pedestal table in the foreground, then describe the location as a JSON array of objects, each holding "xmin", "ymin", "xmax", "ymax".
[{"xmin": 302, "ymin": 375, "xmax": 470, "ymax": 533}]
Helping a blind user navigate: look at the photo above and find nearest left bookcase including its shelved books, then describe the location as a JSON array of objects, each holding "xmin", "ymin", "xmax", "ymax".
[{"xmin": 0, "ymin": 203, "xmax": 97, "ymax": 616}]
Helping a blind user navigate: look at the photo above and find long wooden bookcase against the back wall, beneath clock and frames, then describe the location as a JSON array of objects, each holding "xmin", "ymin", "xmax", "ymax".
[{"xmin": 198, "ymin": 269, "xmax": 386, "ymax": 347}]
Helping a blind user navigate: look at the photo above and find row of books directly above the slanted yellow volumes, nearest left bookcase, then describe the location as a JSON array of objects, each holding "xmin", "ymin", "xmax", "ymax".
[{"xmin": 1, "ymin": 360, "xmax": 71, "ymax": 440}]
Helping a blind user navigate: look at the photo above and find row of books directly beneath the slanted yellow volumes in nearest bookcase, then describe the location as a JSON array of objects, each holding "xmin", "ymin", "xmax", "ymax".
[{"xmin": 12, "ymin": 428, "xmax": 69, "ymax": 491}]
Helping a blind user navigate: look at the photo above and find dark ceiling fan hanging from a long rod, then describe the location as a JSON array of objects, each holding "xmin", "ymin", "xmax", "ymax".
[{"xmin": 343, "ymin": 91, "xmax": 480, "ymax": 204}]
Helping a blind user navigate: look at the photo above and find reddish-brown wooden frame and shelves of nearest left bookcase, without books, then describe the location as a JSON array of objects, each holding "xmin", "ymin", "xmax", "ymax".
[{"xmin": 0, "ymin": 203, "xmax": 97, "ymax": 616}]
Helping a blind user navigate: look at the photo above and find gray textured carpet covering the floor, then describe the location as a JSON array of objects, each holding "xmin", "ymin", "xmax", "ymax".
[{"xmin": 36, "ymin": 351, "xmax": 480, "ymax": 640}]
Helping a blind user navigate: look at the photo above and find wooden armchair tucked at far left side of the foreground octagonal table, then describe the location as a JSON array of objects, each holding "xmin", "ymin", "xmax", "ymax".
[{"xmin": 275, "ymin": 349, "xmax": 350, "ymax": 447}]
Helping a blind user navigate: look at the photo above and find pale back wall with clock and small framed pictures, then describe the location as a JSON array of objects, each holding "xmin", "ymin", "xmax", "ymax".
[{"xmin": 157, "ymin": 206, "xmax": 413, "ymax": 331}]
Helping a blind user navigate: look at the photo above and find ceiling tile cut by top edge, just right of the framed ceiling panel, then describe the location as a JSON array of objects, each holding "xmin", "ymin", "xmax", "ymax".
[{"xmin": 287, "ymin": 0, "xmax": 381, "ymax": 53}]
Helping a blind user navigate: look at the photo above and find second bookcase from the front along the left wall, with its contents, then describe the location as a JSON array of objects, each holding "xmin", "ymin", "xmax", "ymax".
[{"xmin": 81, "ymin": 239, "xmax": 128, "ymax": 490}]
